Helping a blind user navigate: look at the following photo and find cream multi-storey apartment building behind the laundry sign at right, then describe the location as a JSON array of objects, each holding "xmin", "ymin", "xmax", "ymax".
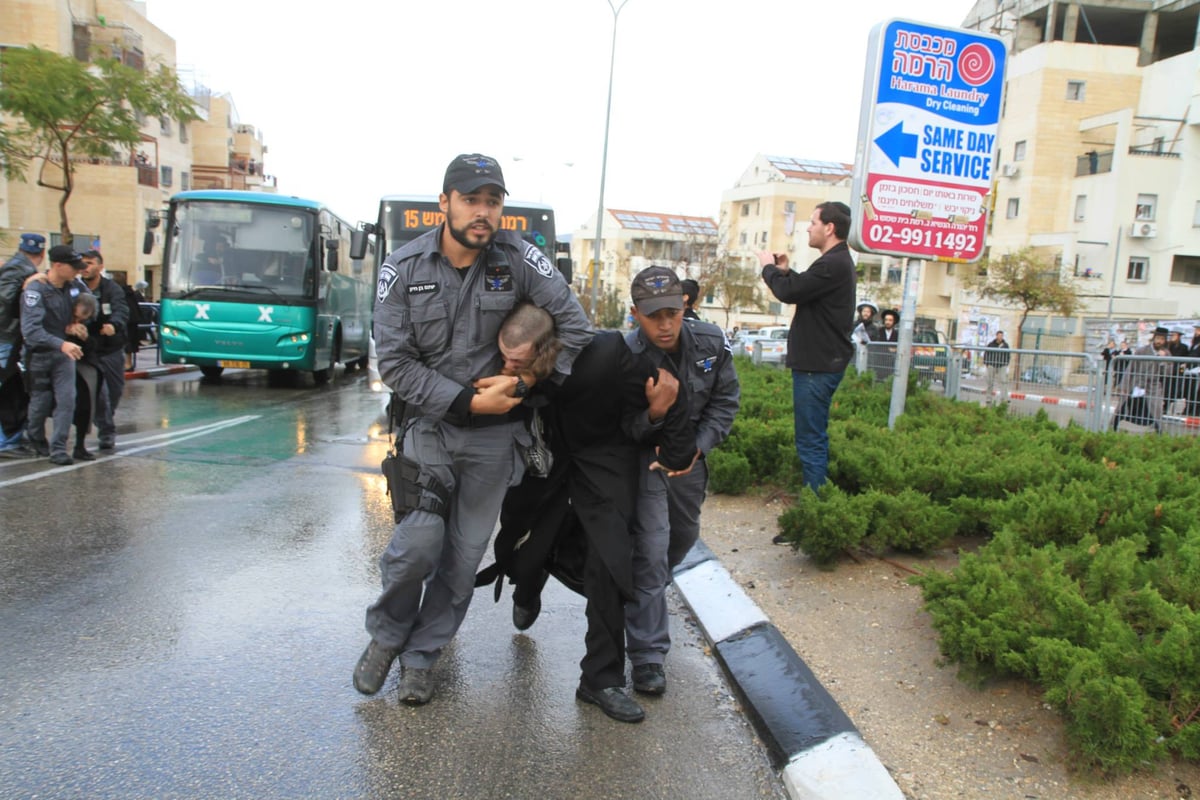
[{"xmin": 953, "ymin": 0, "xmax": 1200, "ymax": 350}]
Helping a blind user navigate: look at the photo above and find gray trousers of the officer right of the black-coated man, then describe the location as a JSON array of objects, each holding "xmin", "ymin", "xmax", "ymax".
[{"xmin": 625, "ymin": 453, "xmax": 708, "ymax": 667}]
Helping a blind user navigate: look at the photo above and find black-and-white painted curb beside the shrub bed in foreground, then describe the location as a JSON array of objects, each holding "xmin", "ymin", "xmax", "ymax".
[{"xmin": 674, "ymin": 542, "xmax": 904, "ymax": 800}]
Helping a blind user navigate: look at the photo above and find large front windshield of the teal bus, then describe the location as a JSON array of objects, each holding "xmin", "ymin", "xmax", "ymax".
[{"xmin": 163, "ymin": 200, "xmax": 317, "ymax": 300}]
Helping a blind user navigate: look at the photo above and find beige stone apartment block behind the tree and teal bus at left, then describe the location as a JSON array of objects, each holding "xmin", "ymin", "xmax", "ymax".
[{"xmin": 0, "ymin": 0, "xmax": 274, "ymax": 297}]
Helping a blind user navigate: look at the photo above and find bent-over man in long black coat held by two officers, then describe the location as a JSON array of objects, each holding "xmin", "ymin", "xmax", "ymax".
[{"xmin": 476, "ymin": 303, "xmax": 696, "ymax": 722}]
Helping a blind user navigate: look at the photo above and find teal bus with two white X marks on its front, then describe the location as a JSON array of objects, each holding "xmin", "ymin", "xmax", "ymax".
[{"xmin": 160, "ymin": 190, "xmax": 377, "ymax": 384}]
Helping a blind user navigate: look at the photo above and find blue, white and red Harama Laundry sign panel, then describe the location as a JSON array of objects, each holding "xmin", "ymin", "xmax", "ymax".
[{"xmin": 850, "ymin": 19, "xmax": 1004, "ymax": 261}]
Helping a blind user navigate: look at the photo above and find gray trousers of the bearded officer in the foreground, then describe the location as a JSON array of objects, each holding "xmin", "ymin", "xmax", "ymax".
[{"xmin": 366, "ymin": 417, "xmax": 529, "ymax": 669}]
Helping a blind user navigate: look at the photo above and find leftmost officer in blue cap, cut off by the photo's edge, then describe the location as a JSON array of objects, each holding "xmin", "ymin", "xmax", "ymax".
[{"xmin": 0, "ymin": 233, "xmax": 46, "ymax": 458}]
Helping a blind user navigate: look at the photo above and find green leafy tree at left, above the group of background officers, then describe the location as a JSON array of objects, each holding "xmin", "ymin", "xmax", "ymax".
[{"xmin": 0, "ymin": 46, "xmax": 199, "ymax": 243}]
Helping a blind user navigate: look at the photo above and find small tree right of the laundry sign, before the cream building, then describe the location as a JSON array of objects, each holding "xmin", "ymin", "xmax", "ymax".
[{"xmin": 965, "ymin": 247, "xmax": 1081, "ymax": 349}]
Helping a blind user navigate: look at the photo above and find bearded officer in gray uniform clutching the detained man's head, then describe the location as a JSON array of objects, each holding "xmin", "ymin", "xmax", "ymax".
[{"xmin": 354, "ymin": 154, "xmax": 592, "ymax": 705}]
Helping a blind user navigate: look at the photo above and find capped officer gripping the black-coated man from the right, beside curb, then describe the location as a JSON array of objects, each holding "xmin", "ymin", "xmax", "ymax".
[{"xmin": 625, "ymin": 266, "xmax": 740, "ymax": 694}]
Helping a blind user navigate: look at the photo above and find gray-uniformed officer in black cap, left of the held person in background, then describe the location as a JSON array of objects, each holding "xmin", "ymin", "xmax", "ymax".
[{"xmin": 20, "ymin": 245, "xmax": 88, "ymax": 464}]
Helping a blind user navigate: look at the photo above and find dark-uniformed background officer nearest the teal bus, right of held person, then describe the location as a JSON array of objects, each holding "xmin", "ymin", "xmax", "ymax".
[{"xmin": 76, "ymin": 249, "xmax": 130, "ymax": 450}]
